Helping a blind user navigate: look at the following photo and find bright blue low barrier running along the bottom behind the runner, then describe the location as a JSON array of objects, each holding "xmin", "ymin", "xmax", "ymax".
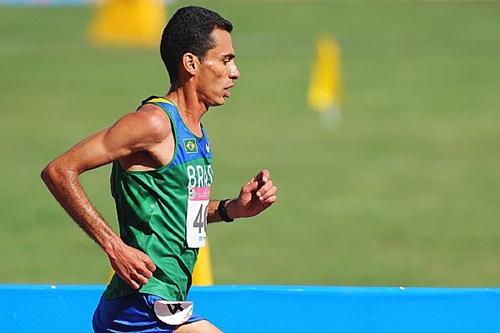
[{"xmin": 0, "ymin": 285, "xmax": 500, "ymax": 333}]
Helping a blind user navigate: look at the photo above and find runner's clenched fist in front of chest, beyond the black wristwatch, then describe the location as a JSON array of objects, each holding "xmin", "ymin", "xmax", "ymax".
[{"xmin": 227, "ymin": 169, "xmax": 278, "ymax": 218}]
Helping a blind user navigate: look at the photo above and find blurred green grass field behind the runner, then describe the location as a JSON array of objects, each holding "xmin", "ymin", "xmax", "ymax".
[{"xmin": 0, "ymin": 1, "xmax": 500, "ymax": 287}]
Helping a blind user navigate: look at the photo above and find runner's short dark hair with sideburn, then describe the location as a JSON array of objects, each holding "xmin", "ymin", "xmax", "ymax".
[{"xmin": 160, "ymin": 6, "xmax": 233, "ymax": 84}]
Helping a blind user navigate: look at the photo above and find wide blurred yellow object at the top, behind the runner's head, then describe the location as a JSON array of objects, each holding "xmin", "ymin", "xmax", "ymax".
[{"xmin": 89, "ymin": 0, "xmax": 167, "ymax": 47}]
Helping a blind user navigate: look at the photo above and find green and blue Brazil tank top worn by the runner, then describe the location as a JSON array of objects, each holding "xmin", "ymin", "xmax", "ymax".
[{"xmin": 104, "ymin": 97, "xmax": 213, "ymax": 301}]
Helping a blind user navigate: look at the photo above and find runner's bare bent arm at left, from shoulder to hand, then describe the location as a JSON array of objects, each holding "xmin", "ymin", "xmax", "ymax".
[{"xmin": 41, "ymin": 107, "xmax": 171, "ymax": 289}]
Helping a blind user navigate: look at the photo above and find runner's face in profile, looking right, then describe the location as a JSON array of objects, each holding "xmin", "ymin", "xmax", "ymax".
[{"xmin": 197, "ymin": 29, "xmax": 240, "ymax": 106}]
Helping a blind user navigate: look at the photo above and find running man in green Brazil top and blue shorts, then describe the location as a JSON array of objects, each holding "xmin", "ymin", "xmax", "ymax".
[{"xmin": 42, "ymin": 6, "xmax": 277, "ymax": 333}]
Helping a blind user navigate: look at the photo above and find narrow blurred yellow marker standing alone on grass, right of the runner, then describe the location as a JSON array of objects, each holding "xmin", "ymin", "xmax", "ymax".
[{"xmin": 308, "ymin": 34, "xmax": 342, "ymax": 112}]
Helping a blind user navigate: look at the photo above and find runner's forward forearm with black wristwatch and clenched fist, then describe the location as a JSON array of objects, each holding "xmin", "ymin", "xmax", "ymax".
[{"xmin": 207, "ymin": 169, "xmax": 278, "ymax": 223}]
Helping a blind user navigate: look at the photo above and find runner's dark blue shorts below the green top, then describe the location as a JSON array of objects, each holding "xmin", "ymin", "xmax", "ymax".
[{"xmin": 92, "ymin": 294, "xmax": 204, "ymax": 333}]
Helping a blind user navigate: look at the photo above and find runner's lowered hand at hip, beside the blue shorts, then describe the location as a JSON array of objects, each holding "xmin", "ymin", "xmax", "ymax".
[{"xmin": 108, "ymin": 243, "xmax": 156, "ymax": 289}]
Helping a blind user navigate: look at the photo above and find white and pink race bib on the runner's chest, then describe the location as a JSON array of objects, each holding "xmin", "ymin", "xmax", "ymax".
[{"xmin": 186, "ymin": 187, "xmax": 210, "ymax": 248}]
